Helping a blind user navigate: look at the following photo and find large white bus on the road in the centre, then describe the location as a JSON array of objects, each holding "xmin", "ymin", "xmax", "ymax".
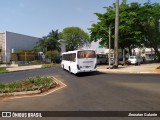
[{"xmin": 61, "ymin": 50, "xmax": 97, "ymax": 74}]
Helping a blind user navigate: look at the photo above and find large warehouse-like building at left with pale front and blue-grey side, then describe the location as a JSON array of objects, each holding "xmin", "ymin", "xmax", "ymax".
[{"xmin": 0, "ymin": 31, "xmax": 39, "ymax": 63}]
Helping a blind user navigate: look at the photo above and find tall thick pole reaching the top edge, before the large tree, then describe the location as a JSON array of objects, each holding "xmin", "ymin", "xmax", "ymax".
[{"xmin": 114, "ymin": 0, "xmax": 119, "ymax": 68}]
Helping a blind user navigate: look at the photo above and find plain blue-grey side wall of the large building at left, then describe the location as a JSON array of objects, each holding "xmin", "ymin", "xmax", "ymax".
[{"xmin": 6, "ymin": 32, "xmax": 39, "ymax": 63}]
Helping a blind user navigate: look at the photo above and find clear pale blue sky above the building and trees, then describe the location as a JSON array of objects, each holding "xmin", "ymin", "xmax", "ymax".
[{"xmin": 0, "ymin": 0, "xmax": 159, "ymax": 37}]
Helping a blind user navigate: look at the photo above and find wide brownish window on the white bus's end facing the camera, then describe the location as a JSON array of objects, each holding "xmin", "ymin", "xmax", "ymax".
[{"xmin": 77, "ymin": 50, "xmax": 96, "ymax": 58}]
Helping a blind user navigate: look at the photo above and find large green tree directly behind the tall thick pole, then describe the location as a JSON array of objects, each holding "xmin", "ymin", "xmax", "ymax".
[{"xmin": 89, "ymin": 0, "xmax": 141, "ymax": 54}]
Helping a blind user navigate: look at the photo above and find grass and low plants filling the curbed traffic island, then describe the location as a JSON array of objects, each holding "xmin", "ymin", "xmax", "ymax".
[{"xmin": 0, "ymin": 76, "xmax": 57, "ymax": 93}]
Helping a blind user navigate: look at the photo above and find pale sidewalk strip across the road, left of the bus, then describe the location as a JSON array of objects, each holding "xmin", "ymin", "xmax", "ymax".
[{"xmin": 7, "ymin": 65, "xmax": 42, "ymax": 72}]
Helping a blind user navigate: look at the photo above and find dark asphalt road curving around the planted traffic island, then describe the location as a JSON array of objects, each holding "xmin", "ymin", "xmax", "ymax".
[{"xmin": 0, "ymin": 67, "xmax": 160, "ymax": 120}]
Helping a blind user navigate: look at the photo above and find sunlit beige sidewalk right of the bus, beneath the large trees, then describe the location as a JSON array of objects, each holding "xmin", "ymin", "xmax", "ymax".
[{"xmin": 97, "ymin": 63, "xmax": 160, "ymax": 74}]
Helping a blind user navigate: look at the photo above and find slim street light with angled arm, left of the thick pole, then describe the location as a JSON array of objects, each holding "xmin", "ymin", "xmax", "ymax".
[{"xmin": 90, "ymin": 21, "xmax": 111, "ymax": 69}]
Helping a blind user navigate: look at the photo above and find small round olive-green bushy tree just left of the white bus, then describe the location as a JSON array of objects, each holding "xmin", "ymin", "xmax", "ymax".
[{"xmin": 46, "ymin": 50, "xmax": 59, "ymax": 62}]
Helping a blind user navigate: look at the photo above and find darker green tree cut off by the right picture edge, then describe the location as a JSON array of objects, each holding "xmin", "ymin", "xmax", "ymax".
[{"xmin": 139, "ymin": 2, "xmax": 160, "ymax": 61}]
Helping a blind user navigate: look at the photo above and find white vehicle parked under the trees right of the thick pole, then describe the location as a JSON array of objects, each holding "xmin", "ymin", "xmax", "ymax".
[{"xmin": 128, "ymin": 56, "xmax": 143, "ymax": 65}]
